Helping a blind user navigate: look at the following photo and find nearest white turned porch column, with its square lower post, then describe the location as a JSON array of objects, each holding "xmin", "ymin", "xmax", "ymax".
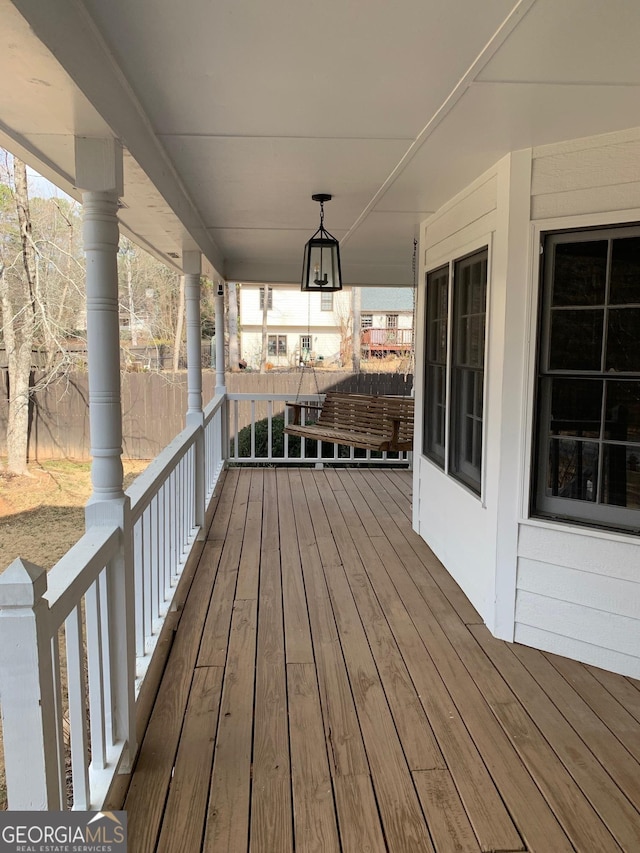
[{"xmin": 75, "ymin": 138, "xmax": 136, "ymax": 772}]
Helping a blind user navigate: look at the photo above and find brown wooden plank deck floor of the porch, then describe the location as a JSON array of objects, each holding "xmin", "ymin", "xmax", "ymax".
[{"xmin": 124, "ymin": 469, "xmax": 640, "ymax": 853}]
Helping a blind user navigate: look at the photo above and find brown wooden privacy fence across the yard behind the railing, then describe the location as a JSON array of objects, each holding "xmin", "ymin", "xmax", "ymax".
[{"xmin": 0, "ymin": 368, "xmax": 413, "ymax": 461}]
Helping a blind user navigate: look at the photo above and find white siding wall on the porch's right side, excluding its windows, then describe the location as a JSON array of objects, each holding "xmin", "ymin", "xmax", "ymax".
[{"xmin": 414, "ymin": 129, "xmax": 640, "ymax": 678}]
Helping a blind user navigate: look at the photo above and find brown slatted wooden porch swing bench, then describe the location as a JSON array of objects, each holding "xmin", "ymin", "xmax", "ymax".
[{"xmin": 284, "ymin": 391, "xmax": 414, "ymax": 451}]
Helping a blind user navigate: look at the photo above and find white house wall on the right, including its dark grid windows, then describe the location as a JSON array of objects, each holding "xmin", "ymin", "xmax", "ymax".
[{"xmin": 413, "ymin": 128, "xmax": 640, "ymax": 678}]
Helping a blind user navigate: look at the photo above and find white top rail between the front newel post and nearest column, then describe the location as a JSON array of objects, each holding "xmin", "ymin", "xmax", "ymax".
[{"xmin": 43, "ymin": 527, "xmax": 121, "ymax": 624}]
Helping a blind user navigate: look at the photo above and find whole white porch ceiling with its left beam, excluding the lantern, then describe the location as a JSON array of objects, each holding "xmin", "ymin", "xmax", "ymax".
[{"xmin": 0, "ymin": 0, "xmax": 640, "ymax": 285}]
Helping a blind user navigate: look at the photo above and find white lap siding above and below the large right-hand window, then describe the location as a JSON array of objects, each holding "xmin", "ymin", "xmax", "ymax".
[{"xmin": 515, "ymin": 129, "xmax": 640, "ymax": 678}]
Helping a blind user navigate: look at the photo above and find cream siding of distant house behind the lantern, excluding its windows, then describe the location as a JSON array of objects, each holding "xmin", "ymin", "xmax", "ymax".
[{"xmin": 240, "ymin": 284, "xmax": 351, "ymax": 367}]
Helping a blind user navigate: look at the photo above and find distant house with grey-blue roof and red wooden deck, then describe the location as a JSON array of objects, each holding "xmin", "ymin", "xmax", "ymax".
[{"xmin": 360, "ymin": 287, "xmax": 414, "ymax": 358}]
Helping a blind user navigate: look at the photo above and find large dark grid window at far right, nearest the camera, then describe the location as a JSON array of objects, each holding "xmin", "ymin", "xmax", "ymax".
[{"xmin": 532, "ymin": 226, "xmax": 640, "ymax": 532}]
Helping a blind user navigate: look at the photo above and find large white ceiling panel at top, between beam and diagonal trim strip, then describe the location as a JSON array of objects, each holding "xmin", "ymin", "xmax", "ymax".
[{"xmin": 86, "ymin": 0, "xmax": 514, "ymax": 138}]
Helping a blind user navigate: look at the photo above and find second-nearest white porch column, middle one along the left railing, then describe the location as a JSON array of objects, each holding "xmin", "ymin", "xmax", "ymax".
[{"xmin": 182, "ymin": 252, "xmax": 205, "ymax": 539}]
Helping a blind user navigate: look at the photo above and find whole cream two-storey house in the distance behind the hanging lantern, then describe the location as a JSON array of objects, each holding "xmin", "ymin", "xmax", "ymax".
[{"xmin": 240, "ymin": 284, "xmax": 352, "ymax": 368}]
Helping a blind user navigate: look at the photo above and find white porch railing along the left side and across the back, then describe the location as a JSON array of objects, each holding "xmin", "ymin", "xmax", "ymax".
[{"xmin": 0, "ymin": 394, "xmax": 410, "ymax": 810}]
